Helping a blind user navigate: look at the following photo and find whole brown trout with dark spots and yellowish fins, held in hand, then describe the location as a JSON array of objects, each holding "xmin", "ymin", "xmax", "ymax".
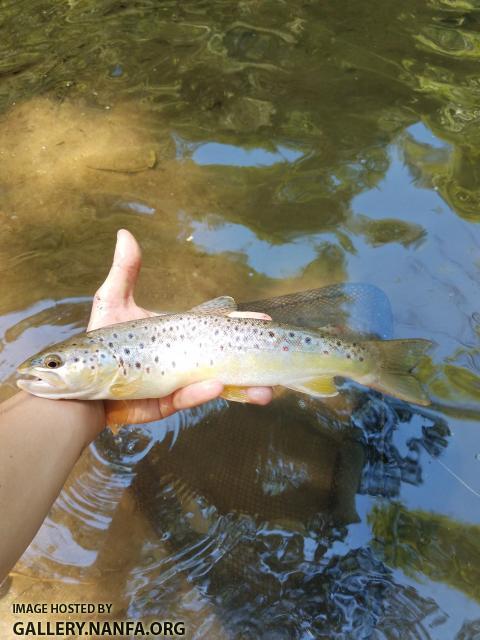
[{"xmin": 17, "ymin": 296, "xmax": 432, "ymax": 405}]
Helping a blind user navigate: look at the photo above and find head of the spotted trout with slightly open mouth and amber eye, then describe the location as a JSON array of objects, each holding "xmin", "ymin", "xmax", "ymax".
[{"xmin": 17, "ymin": 333, "xmax": 118, "ymax": 400}]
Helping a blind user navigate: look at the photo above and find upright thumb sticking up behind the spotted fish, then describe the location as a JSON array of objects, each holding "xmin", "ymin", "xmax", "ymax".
[{"xmin": 100, "ymin": 229, "xmax": 142, "ymax": 301}]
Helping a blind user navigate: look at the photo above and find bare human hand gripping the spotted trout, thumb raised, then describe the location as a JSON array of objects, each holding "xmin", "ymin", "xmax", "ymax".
[{"xmin": 88, "ymin": 229, "xmax": 272, "ymax": 427}]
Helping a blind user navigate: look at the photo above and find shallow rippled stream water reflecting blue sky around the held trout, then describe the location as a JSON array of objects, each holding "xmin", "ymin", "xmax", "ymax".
[{"xmin": 0, "ymin": 0, "xmax": 480, "ymax": 640}]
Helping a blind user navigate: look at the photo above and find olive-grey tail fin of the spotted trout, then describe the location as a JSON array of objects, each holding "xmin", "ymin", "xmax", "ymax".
[{"xmin": 368, "ymin": 339, "xmax": 433, "ymax": 406}]
